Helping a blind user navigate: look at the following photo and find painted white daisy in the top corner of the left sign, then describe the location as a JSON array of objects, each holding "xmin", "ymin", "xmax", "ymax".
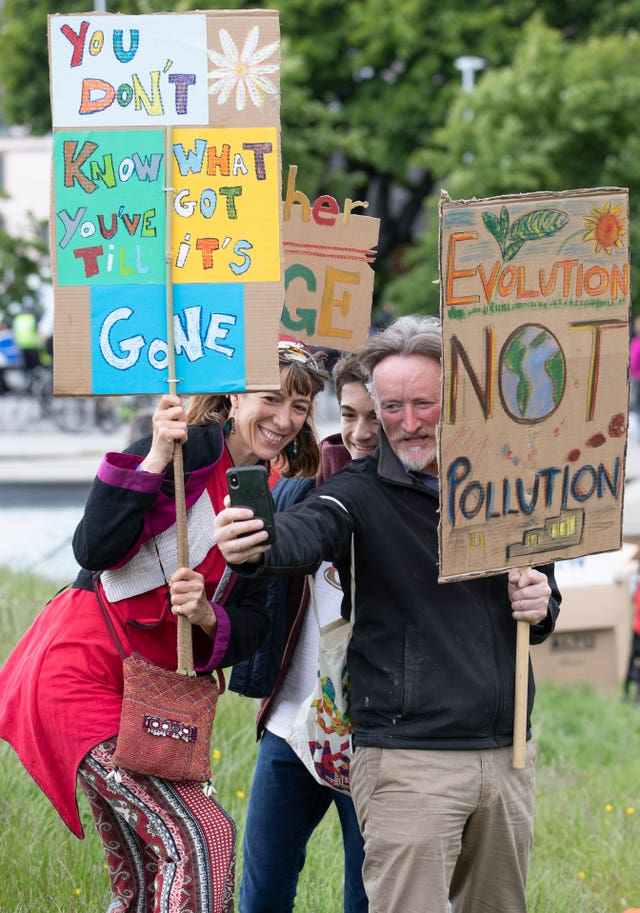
[{"xmin": 207, "ymin": 25, "xmax": 280, "ymax": 111}]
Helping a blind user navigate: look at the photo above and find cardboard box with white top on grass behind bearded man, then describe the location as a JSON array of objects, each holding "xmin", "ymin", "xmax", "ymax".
[{"xmin": 531, "ymin": 553, "xmax": 633, "ymax": 692}]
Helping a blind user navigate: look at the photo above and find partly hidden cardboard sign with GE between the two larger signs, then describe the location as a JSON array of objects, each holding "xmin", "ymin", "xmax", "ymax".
[{"xmin": 280, "ymin": 165, "xmax": 380, "ymax": 352}]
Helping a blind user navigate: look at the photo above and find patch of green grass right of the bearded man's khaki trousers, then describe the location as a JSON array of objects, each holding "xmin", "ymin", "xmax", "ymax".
[{"xmin": 528, "ymin": 684, "xmax": 640, "ymax": 913}]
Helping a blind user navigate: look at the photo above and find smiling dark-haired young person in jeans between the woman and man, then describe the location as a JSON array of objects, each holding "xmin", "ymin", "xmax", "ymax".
[{"xmin": 229, "ymin": 353, "xmax": 378, "ymax": 913}]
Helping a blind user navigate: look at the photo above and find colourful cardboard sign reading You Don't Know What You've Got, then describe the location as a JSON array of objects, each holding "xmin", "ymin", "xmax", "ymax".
[{"xmin": 49, "ymin": 10, "xmax": 284, "ymax": 395}]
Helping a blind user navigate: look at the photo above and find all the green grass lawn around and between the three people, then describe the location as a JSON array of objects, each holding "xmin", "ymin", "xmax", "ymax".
[{"xmin": 0, "ymin": 569, "xmax": 640, "ymax": 913}]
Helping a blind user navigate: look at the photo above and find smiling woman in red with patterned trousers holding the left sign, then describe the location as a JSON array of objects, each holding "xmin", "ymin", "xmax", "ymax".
[{"xmin": 0, "ymin": 340, "xmax": 326, "ymax": 913}]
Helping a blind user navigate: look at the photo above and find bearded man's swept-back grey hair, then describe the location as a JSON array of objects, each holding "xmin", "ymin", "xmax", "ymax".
[{"xmin": 358, "ymin": 314, "xmax": 442, "ymax": 378}]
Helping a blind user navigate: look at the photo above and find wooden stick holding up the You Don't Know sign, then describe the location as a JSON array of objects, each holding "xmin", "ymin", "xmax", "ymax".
[{"xmin": 164, "ymin": 125, "xmax": 195, "ymax": 675}]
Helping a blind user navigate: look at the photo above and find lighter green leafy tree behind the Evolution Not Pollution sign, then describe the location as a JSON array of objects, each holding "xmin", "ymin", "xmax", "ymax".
[{"xmin": 388, "ymin": 15, "xmax": 640, "ymax": 313}]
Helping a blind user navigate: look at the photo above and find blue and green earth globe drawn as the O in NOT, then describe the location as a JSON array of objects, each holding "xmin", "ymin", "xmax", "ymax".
[{"xmin": 500, "ymin": 323, "xmax": 567, "ymax": 423}]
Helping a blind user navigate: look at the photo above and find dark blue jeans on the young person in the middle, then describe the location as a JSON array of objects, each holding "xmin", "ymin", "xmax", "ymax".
[{"xmin": 239, "ymin": 731, "xmax": 368, "ymax": 913}]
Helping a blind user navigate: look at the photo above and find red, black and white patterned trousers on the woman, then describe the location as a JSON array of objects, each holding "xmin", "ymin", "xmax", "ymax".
[{"xmin": 78, "ymin": 739, "xmax": 236, "ymax": 913}]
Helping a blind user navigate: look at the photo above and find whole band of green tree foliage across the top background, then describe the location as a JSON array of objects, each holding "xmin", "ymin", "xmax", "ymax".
[{"xmin": 0, "ymin": 0, "xmax": 640, "ymax": 320}]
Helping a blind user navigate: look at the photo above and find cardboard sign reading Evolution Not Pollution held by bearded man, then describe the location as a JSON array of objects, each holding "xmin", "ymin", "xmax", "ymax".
[{"xmin": 439, "ymin": 187, "xmax": 630, "ymax": 580}]
